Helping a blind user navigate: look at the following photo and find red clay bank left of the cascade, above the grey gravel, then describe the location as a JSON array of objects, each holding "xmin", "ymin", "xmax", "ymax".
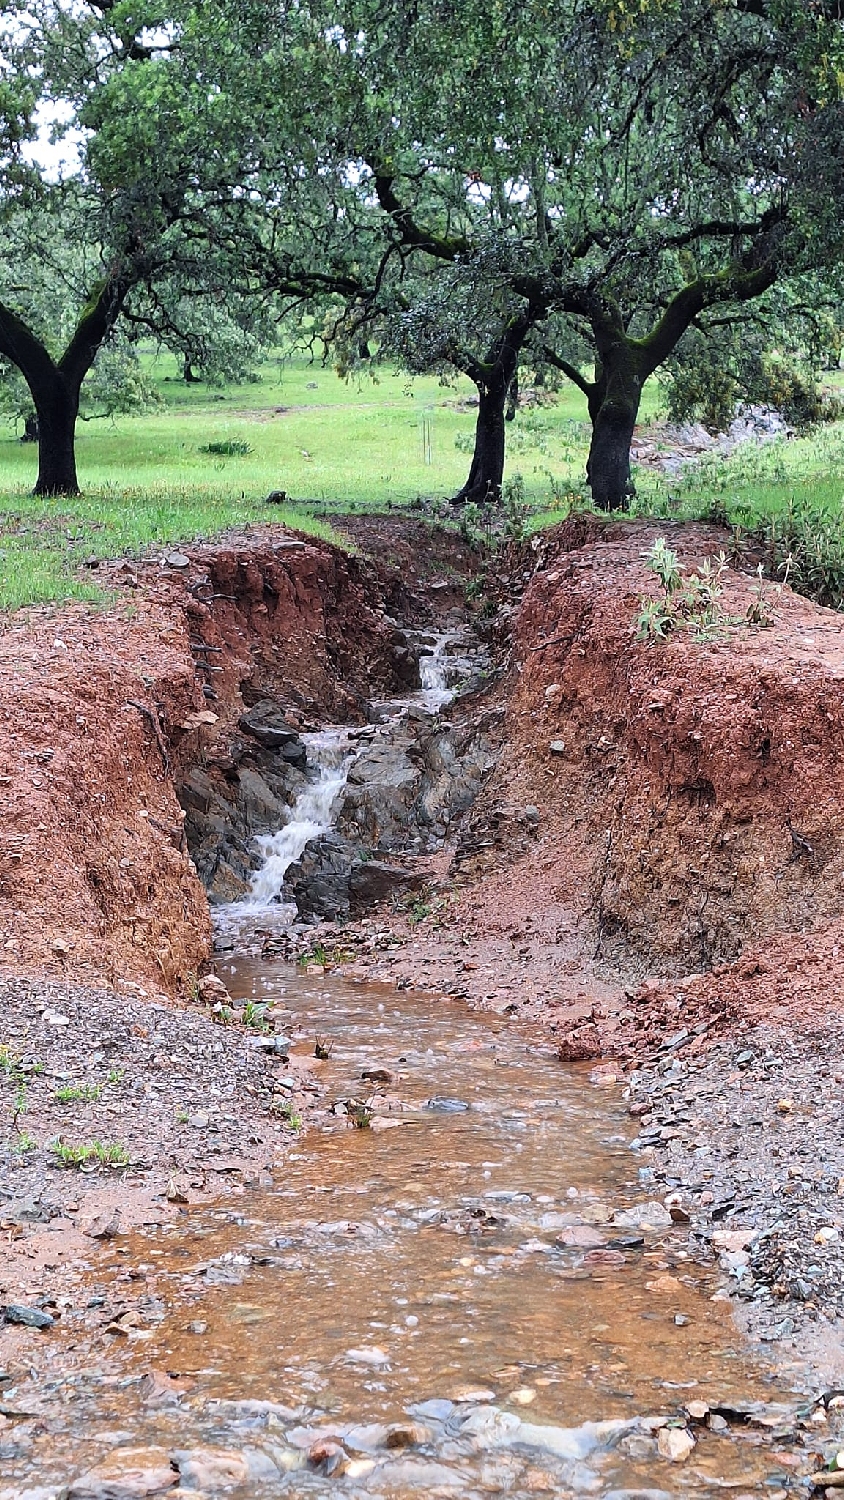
[{"xmin": 0, "ymin": 527, "xmax": 428, "ymax": 993}]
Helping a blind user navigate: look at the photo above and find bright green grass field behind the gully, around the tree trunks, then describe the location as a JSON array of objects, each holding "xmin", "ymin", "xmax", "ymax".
[{"xmin": 0, "ymin": 348, "xmax": 844, "ymax": 609}]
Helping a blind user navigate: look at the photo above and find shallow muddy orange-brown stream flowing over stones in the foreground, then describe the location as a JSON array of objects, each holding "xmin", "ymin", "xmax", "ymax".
[{"xmin": 8, "ymin": 962, "xmax": 799, "ymax": 1500}]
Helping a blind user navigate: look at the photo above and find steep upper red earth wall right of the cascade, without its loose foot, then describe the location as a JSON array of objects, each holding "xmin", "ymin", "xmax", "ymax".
[{"xmin": 500, "ymin": 524, "xmax": 844, "ymax": 974}]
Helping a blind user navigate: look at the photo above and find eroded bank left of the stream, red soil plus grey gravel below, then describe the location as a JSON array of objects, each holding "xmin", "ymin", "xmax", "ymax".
[{"xmin": 0, "ymin": 527, "xmax": 471, "ymax": 1302}]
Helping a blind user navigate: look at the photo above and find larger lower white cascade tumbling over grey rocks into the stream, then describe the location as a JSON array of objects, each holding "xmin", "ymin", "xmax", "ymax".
[{"xmin": 237, "ymin": 729, "xmax": 358, "ymax": 914}]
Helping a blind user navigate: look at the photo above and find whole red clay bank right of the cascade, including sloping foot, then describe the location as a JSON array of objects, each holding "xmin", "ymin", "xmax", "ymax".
[{"xmin": 356, "ymin": 522, "xmax": 844, "ymax": 1059}]
